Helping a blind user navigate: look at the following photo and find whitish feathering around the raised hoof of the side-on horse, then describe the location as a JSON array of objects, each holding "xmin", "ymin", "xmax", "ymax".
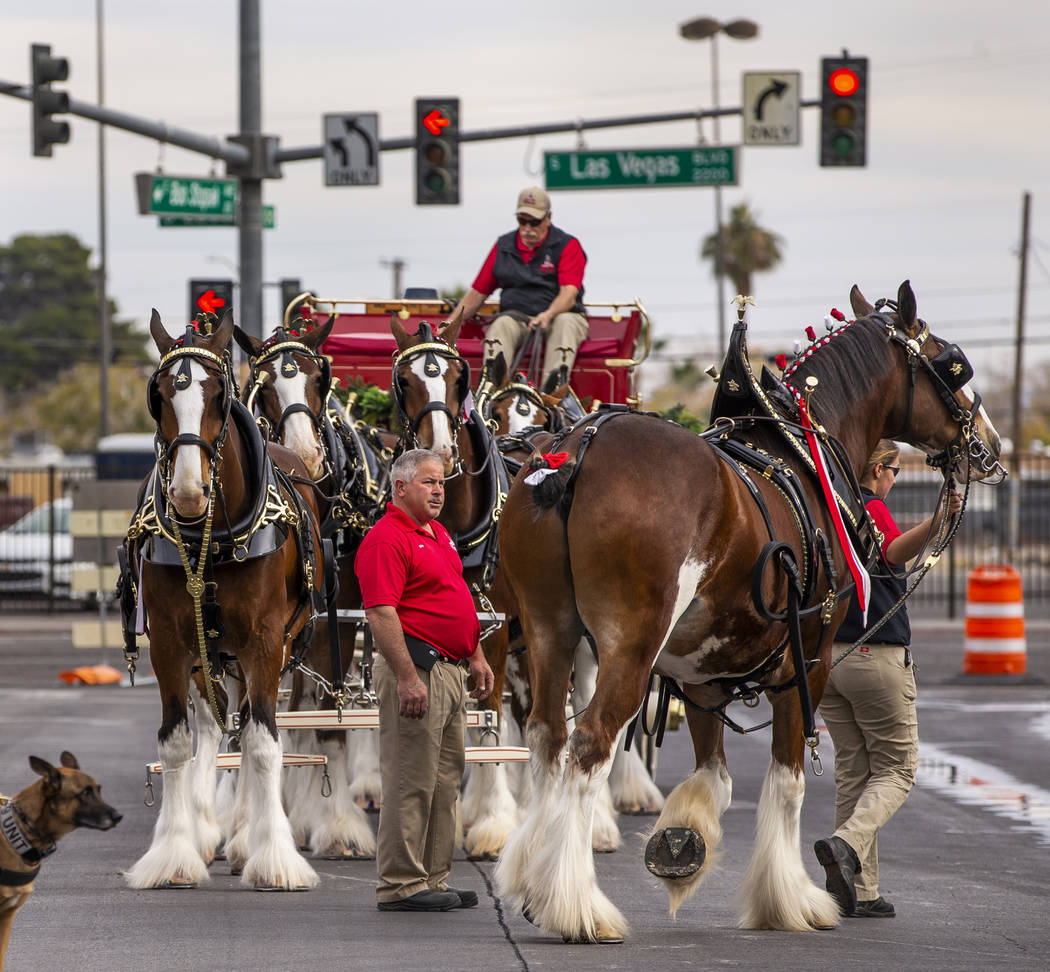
[{"xmin": 652, "ymin": 762, "xmax": 733, "ymax": 917}]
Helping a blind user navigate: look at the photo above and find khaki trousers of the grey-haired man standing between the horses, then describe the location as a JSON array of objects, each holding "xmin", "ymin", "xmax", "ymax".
[{"xmin": 373, "ymin": 656, "xmax": 466, "ymax": 902}]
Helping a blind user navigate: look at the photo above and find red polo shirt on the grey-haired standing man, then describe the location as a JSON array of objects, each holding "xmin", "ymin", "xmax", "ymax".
[{"xmin": 354, "ymin": 503, "xmax": 481, "ymax": 661}]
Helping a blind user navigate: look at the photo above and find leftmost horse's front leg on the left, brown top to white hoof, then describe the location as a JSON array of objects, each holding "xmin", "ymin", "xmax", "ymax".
[{"xmin": 124, "ymin": 646, "xmax": 208, "ymax": 889}]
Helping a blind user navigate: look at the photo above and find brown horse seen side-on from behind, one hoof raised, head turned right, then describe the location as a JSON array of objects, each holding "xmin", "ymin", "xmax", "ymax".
[{"xmin": 497, "ymin": 282, "xmax": 1000, "ymax": 942}]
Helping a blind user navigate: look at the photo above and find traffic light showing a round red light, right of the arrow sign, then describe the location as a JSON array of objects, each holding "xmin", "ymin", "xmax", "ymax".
[{"xmin": 820, "ymin": 52, "xmax": 867, "ymax": 166}]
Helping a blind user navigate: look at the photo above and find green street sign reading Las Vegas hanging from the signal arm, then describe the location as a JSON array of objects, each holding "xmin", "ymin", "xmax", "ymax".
[{"xmin": 543, "ymin": 145, "xmax": 739, "ymax": 189}]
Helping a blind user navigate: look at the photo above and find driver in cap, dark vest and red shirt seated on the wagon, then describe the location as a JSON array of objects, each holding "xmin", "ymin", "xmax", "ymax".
[{"xmin": 453, "ymin": 186, "xmax": 587, "ymax": 392}]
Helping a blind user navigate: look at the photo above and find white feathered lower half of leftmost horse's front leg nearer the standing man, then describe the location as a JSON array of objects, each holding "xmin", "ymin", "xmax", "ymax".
[{"xmin": 240, "ymin": 720, "xmax": 320, "ymax": 889}]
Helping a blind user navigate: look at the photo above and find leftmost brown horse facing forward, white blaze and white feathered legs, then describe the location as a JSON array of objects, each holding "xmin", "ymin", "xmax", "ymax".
[{"xmin": 125, "ymin": 311, "xmax": 324, "ymax": 890}]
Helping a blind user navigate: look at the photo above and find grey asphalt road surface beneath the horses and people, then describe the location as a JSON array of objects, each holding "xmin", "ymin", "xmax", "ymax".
[{"xmin": 0, "ymin": 615, "xmax": 1050, "ymax": 972}]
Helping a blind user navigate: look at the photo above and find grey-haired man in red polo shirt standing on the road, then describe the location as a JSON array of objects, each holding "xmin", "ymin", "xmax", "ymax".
[{"xmin": 354, "ymin": 449, "xmax": 492, "ymax": 911}]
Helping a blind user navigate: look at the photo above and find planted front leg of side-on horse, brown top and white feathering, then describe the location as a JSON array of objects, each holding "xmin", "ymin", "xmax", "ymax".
[{"xmin": 738, "ymin": 667, "xmax": 841, "ymax": 931}]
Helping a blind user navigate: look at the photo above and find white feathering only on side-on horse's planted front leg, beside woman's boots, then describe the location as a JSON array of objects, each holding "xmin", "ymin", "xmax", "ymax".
[{"xmin": 737, "ymin": 761, "xmax": 840, "ymax": 931}]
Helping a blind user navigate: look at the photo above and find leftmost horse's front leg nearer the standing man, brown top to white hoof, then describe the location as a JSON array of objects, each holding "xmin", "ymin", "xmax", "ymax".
[{"xmin": 238, "ymin": 625, "xmax": 319, "ymax": 891}]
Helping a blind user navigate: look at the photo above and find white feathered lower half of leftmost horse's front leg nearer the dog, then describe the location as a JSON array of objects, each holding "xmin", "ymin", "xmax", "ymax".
[{"xmin": 124, "ymin": 722, "xmax": 208, "ymax": 889}]
